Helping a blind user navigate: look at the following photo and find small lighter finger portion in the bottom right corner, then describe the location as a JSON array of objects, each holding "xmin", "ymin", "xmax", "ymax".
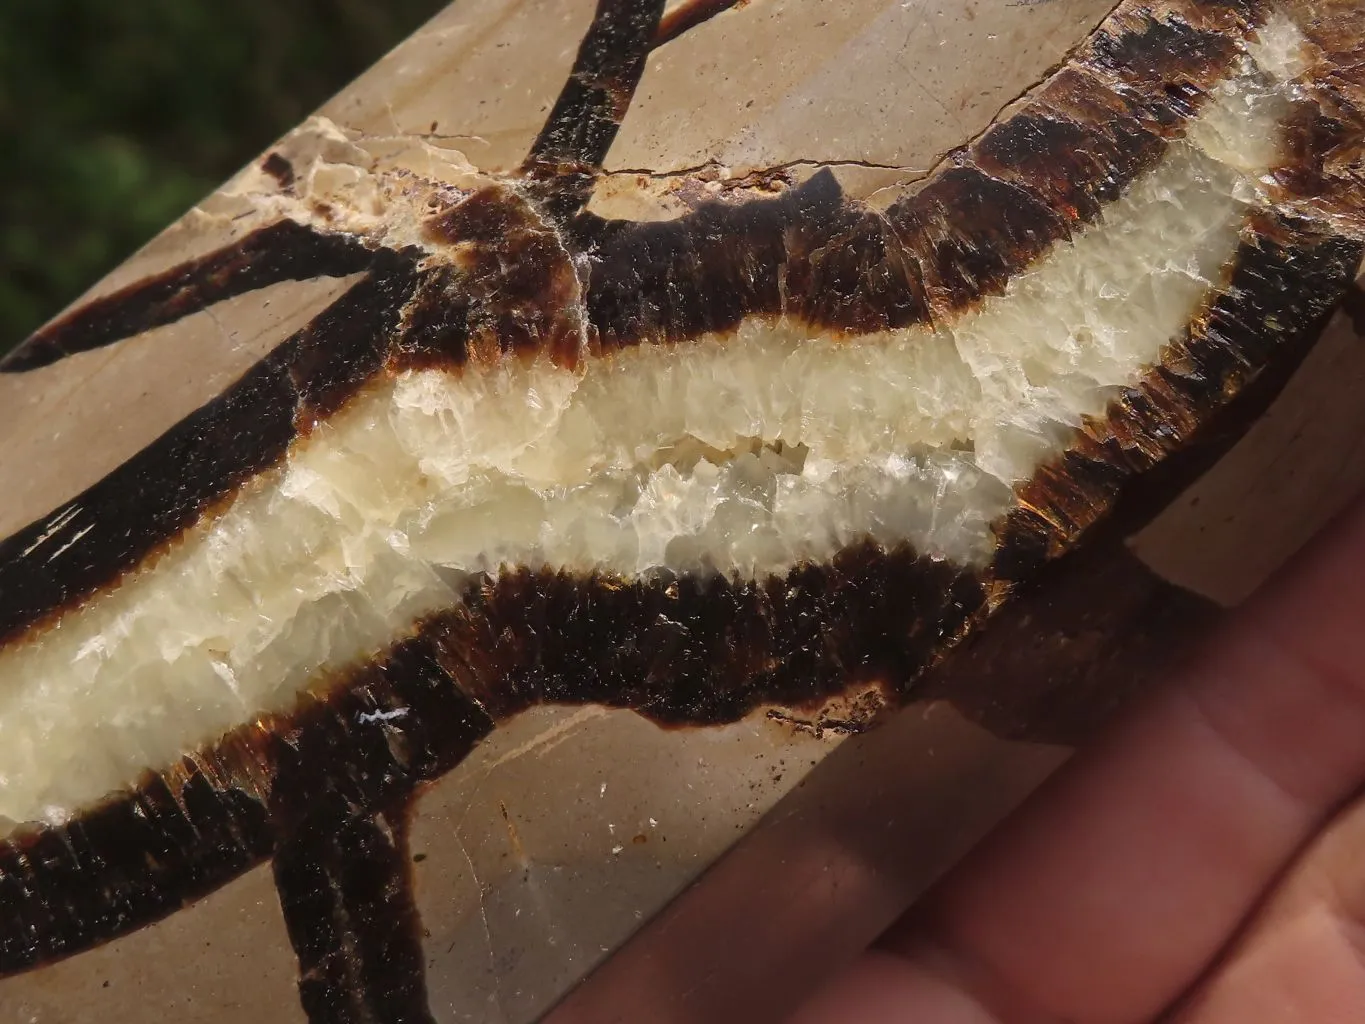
[{"xmin": 1171, "ymin": 797, "xmax": 1365, "ymax": 1024}]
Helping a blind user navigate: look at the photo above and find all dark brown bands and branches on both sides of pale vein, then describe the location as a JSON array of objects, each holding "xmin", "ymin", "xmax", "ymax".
[{"xmin": 0, "ymin": 0, "xmax": 1362, "ymax": 1024}]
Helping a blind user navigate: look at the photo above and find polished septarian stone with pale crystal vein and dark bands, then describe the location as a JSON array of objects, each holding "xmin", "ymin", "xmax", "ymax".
[{"xmin": 0, "ymin": 0, "xmax": 1365, "ymax": 1024}]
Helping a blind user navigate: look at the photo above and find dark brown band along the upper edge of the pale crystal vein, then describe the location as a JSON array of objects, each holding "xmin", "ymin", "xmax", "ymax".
[{"xmin": 0, "ymin": 3, "xmax": 1266, "ymax": 640}]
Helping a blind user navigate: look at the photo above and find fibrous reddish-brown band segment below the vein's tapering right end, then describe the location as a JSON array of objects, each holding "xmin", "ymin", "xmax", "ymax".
[{"xmin": 990, "ymin": 214, "xmax": 1365, "ymax": 583}]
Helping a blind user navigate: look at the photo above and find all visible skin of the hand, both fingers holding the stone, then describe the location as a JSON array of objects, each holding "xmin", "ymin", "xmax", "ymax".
[{"xmin": 789, "ymin": 505, "xmax": 1365, "ymax": 1024}]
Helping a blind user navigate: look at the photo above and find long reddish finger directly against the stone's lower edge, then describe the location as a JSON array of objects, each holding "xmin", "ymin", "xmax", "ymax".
[{"xmin": 799, "ymin": 499, "xmax": 1365, "ymax": 1024}]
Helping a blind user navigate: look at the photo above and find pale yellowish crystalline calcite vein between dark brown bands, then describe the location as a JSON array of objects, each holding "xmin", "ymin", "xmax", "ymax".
[{"xmin": 0, "ymin": 23, "xmax": 1301, "ymax": 822}]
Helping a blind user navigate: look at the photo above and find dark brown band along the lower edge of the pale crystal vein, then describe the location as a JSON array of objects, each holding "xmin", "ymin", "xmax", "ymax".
[{"xmin": 0, "ymin": 206, "xmax": 1362, "ymax": 988}]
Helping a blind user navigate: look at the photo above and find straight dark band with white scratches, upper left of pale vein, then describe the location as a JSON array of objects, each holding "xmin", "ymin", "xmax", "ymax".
[{"xmin": 0, "ymin": 254, "xmax": 415, "ymax": 643}]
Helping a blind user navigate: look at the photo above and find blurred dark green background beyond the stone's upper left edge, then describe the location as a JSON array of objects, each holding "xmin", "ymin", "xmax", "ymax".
[{"xmin": 0, "ymin": 0, "xmax": 448, "ymax": 354}]
